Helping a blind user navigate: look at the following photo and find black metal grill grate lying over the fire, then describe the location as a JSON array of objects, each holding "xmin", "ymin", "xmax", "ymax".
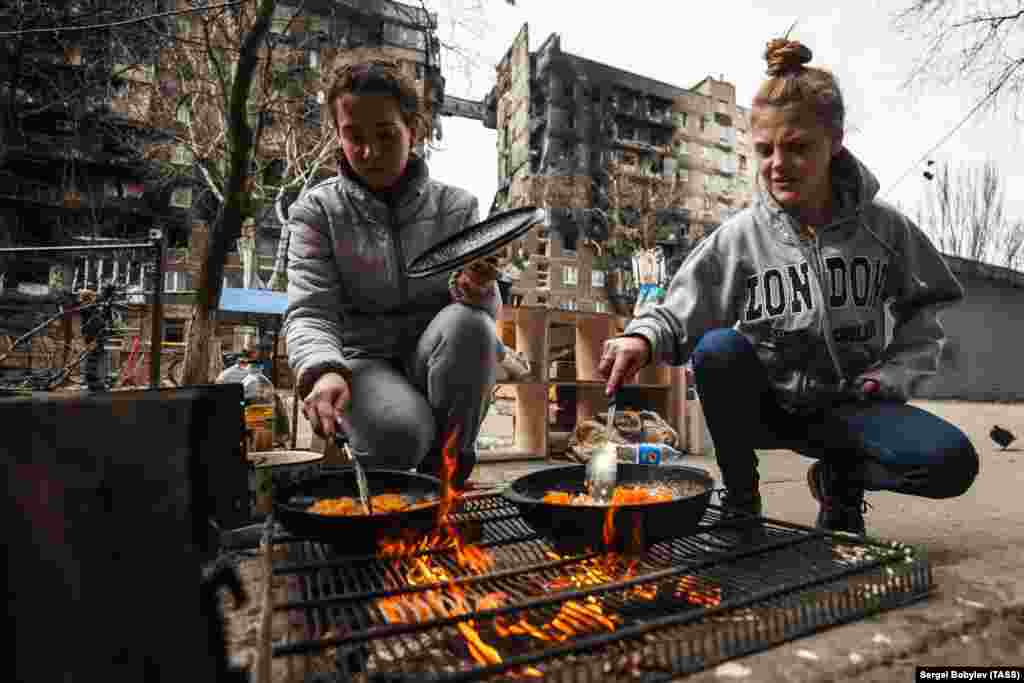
[{"xmin": 273, "ymin": 495, "xmax": 932, "ymax": 682}]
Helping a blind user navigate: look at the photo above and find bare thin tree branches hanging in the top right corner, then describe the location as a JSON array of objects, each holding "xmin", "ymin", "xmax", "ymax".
[{"xmin": 894, "ymin": 0, "xmax": 1024, "ymax": 113}]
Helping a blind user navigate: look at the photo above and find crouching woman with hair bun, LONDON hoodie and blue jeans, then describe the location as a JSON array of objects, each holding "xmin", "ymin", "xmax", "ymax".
[{"xmin": 599, "ymin": 40, "xmax": 978, "ymax": 532}]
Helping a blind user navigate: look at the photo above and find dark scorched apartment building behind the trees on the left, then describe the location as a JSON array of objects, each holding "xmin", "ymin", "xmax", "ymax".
[{"xmin": 0, "ymin": 0, "xmax": 444, "ymax": 374}]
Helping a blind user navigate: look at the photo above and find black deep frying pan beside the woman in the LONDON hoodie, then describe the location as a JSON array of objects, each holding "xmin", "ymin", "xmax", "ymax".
[{"xmin": 502, "ymin": 463, "xmax": 715, "ymax": 553}]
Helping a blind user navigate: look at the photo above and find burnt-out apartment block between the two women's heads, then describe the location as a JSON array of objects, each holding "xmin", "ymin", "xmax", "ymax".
[{"xmin": 484, "ymin": 25, "xmax": 754, "ymax": 312}]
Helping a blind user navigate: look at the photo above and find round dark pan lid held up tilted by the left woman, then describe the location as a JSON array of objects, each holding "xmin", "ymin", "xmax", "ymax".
[{"xmin": 406, "ymin": 207, "xmax": 547, "ymax": 278}]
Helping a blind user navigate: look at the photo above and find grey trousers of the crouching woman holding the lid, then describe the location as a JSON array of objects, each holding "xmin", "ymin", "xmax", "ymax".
[{"xmin": 342, "ymin": 303, "xmax": 498, "ymax": 485}]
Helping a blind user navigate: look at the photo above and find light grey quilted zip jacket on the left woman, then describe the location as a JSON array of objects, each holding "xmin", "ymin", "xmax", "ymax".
[{"xmin": 285, "ymin": 158, "xmax": 501, "ymax": 397}]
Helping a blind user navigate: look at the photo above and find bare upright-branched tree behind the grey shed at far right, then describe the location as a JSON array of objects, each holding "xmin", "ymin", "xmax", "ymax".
[{"xmin": 918, "ymin": 162, "xmax": 1024, "ymax": 267}]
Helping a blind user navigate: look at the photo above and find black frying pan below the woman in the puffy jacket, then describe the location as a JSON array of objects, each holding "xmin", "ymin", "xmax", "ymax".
[{"xmin": 273, "ymin": 468, "xmax": 441, "ymax": 555}]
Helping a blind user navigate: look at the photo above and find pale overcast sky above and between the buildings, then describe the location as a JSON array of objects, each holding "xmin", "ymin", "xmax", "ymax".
[{"xmin": 430, "ymin": 0, "xmax": 1024, "ymax": 218}]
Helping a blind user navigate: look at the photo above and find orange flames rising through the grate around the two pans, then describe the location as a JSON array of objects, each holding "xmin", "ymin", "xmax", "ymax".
[{"xmin": 376, "ymin": 426, "xmax": 721, "ymax": 678}]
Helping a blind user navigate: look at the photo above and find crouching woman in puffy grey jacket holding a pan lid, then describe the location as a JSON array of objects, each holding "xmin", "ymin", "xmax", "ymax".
[{"xmin": 285, "ymin": 62, "xmax": 501, "ymax": 486}]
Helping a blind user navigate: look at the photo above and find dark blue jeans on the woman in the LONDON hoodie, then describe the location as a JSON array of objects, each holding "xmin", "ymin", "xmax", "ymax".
[{"xmin": 691, "ymin": 329, "xmax": 978, "ymax": 498}]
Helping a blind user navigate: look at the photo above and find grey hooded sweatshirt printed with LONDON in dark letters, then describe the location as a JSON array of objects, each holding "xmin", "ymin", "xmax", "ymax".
[{"xmin": 625, "ymin": 150, "xmax": 964, "ymax": 413}]
